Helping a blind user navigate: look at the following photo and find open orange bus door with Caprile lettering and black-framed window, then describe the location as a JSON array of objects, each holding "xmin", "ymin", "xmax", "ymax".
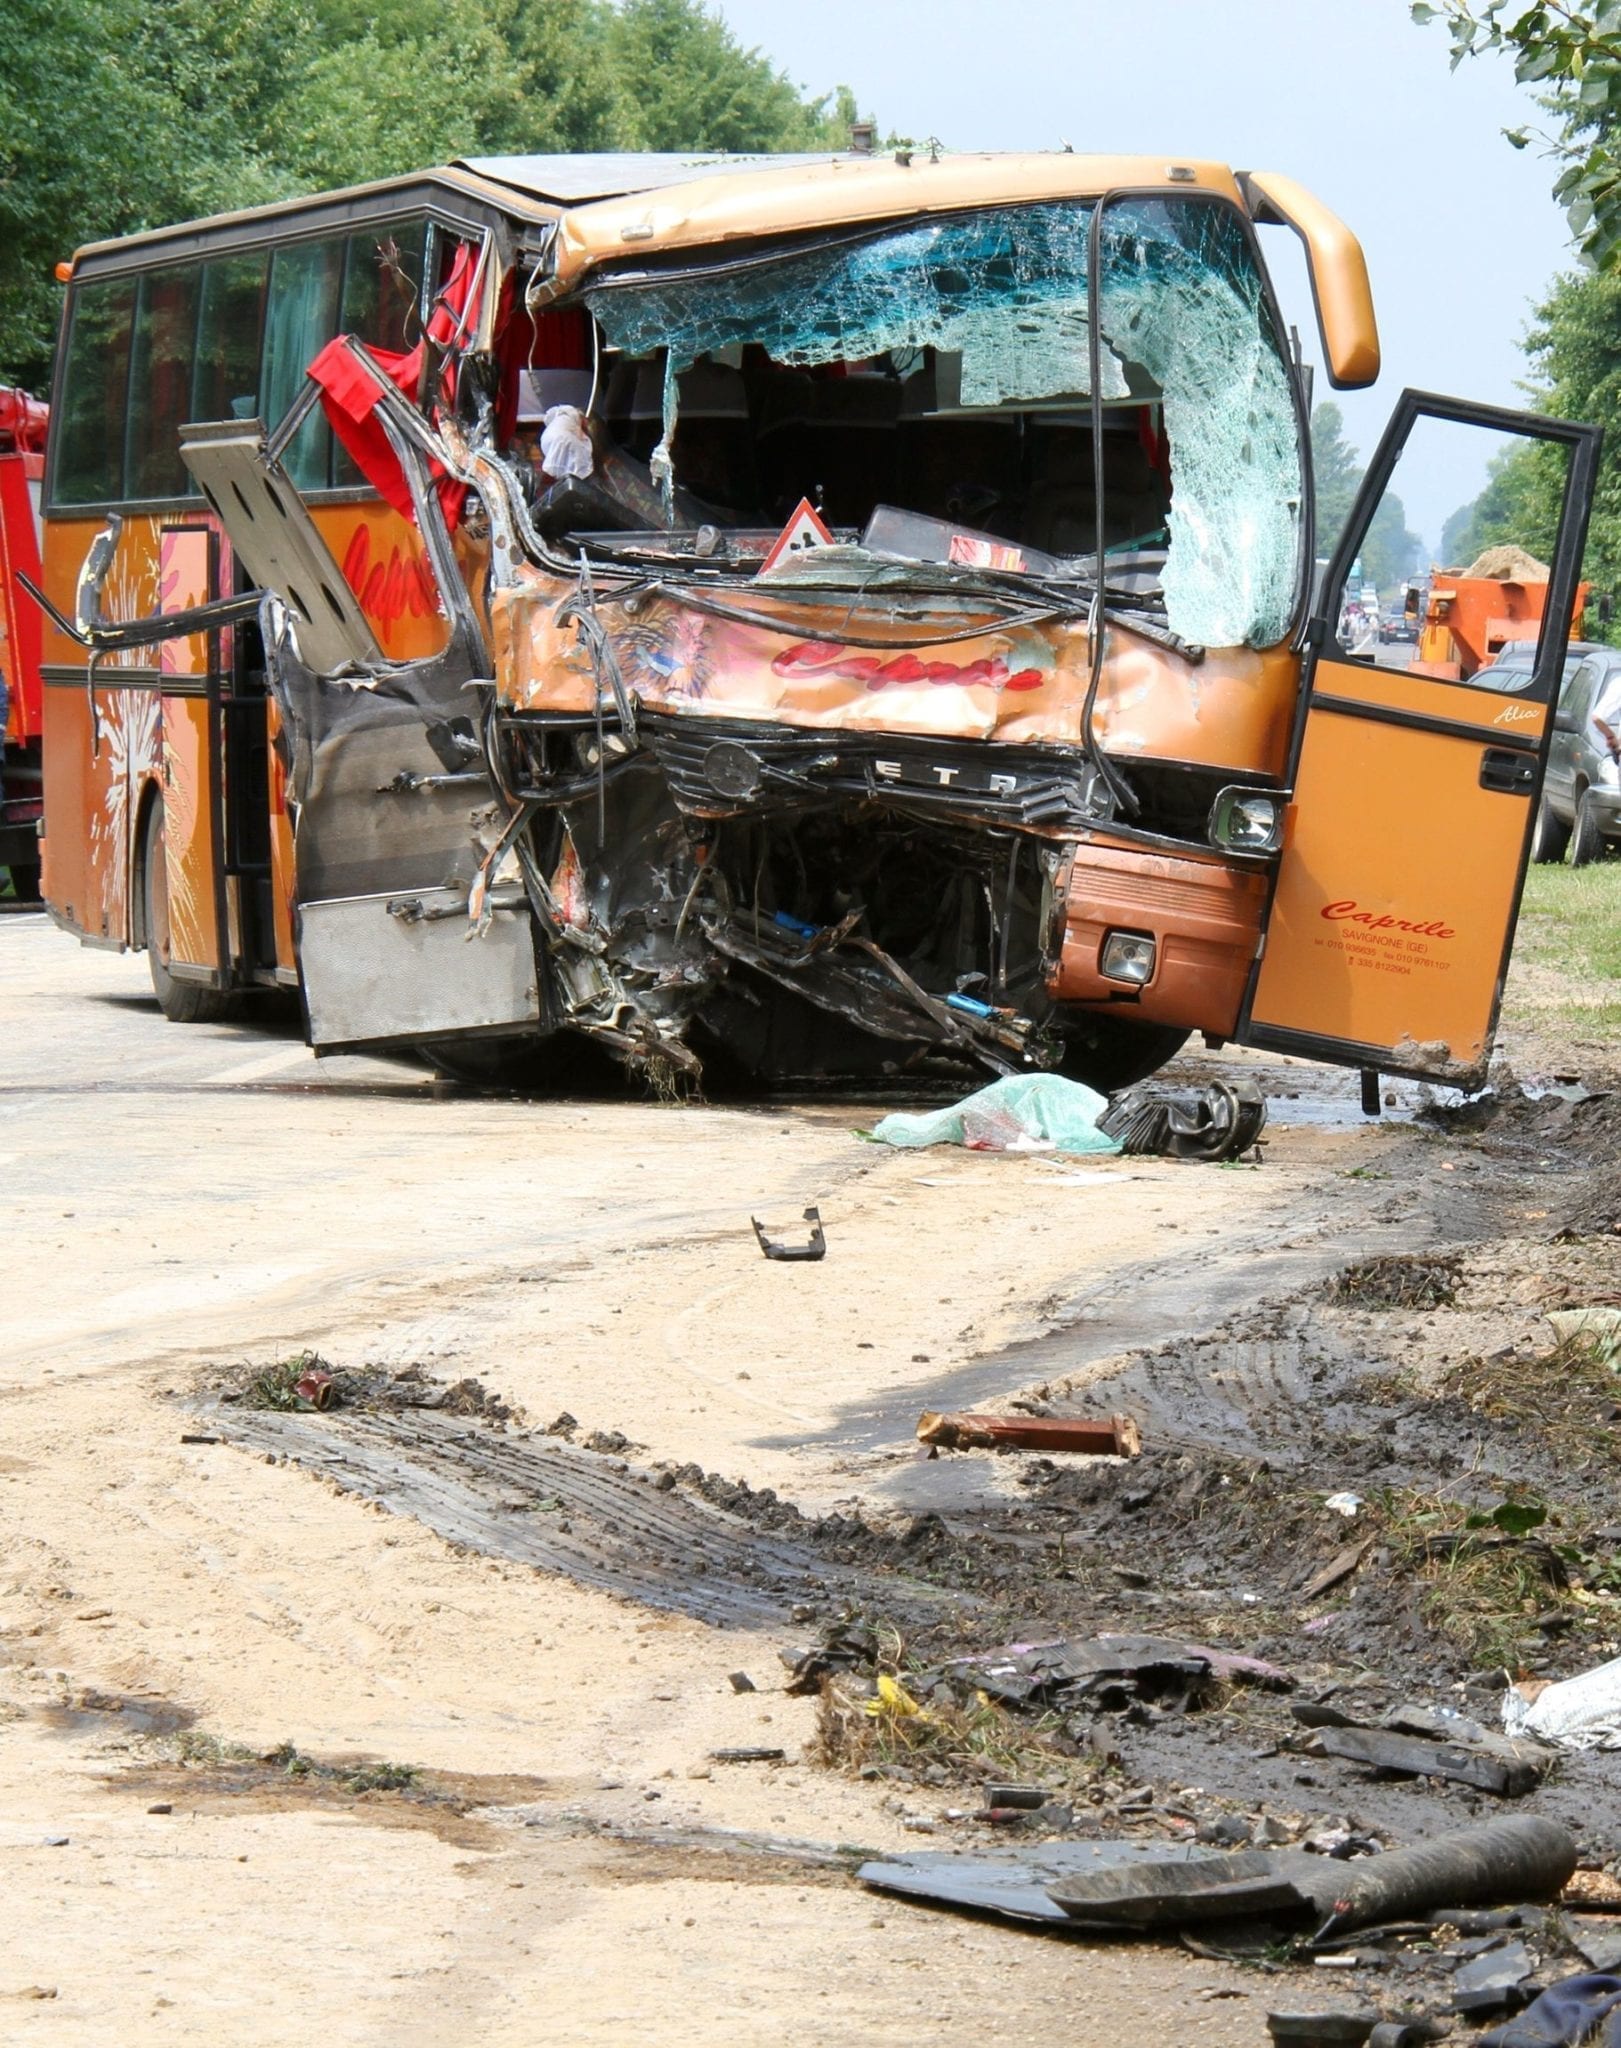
[{"xmin": 1238, "ymin": 391, "xmax": 1603, "ymax": 1087}]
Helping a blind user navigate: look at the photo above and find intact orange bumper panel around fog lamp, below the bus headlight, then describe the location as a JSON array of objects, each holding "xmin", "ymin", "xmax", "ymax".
[{"xmin": 1048, "ymin": 846, "xmax": 1267, "ymax": 1038}]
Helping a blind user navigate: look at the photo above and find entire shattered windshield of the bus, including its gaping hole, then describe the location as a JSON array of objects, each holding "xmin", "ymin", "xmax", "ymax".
[{"xmin": 587, "ymin": 199, "xmax": 1302, "ymax": 647}]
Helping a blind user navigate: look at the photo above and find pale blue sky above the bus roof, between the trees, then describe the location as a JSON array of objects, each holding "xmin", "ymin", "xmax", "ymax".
[{"xmin": 712, "ymin": 0, "xmax": 1572, "ymax": 547}]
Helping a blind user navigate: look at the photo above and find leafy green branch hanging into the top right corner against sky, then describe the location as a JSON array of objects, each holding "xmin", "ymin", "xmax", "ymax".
[{"xmin": 1412, "ymin": 0, "xmax": 1621, "ymax": 270}]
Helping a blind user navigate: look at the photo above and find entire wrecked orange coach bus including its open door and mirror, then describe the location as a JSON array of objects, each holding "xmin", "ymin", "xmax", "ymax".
[{"xmin": 31, "ymin": 150, "xmax": 1598, "ymax": 1087}]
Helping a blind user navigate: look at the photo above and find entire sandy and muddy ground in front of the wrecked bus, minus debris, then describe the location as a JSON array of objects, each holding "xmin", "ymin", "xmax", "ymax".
[{"xmin": 0, "ymin": 915, "xmax": 1621, "ymax": 2044}]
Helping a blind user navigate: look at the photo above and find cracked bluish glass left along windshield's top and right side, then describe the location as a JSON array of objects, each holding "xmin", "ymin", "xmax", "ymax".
[{"xmin": 587, "ymin": 199, "xmax": 1302, "ymax": 647}]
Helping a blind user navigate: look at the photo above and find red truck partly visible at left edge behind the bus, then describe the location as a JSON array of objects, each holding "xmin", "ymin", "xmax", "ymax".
[{"xmin": 0, "ymin": 385, "xmax": 49, "ymax": 901}]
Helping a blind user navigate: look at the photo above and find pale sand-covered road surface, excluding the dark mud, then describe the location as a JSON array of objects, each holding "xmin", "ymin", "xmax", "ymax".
[{"xmin": 0, "ymin": 915, "xmax": 1427, "ymax": 2048}]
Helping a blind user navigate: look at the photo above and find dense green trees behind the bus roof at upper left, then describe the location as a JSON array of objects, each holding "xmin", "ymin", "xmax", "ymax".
[{"xmin": 0, "ymin": 0, "xmax": 871, "ymax": 389}]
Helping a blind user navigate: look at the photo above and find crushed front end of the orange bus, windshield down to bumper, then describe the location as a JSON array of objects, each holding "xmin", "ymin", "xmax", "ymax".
[{"xmin": 435, "ymin": 180, "xmax": 1310, "ymax": 1085}]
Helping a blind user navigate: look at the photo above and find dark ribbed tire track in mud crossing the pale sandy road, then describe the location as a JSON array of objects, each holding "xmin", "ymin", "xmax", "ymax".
[{"xmin": 188, "ymin": 1399, "xmax": 892, "ymax": 1628}]
